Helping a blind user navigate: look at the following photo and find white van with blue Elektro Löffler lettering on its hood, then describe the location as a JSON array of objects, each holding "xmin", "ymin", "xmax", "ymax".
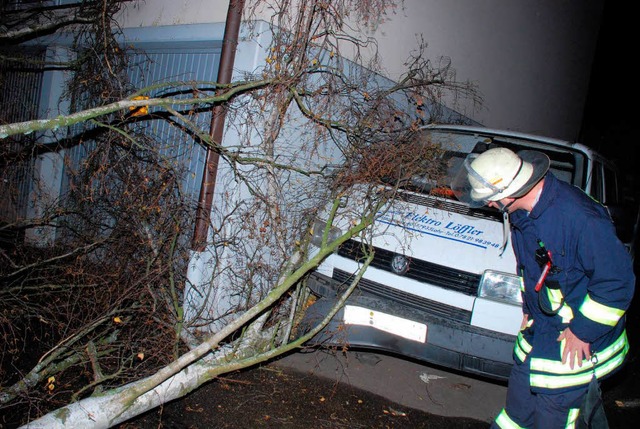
[{"xmin": 305, "ymin": 126, "xmax": 637, "ymax": 380}]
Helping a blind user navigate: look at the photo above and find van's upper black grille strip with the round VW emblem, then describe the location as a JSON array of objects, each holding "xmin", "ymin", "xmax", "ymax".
[{"xmin": 338, "ymin": 240, "xmax": 481, "ymax": 296}]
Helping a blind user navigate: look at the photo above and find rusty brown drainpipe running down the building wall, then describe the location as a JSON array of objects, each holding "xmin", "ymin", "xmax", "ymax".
[{"xmin": 191, "ymin": 0, "xmax": 244, "ymax": 252}]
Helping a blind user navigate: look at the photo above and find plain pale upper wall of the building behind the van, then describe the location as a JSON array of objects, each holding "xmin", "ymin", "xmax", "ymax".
[{"xmin": 116, "ymin": 0, "xmax": 604, "ymax": 140}]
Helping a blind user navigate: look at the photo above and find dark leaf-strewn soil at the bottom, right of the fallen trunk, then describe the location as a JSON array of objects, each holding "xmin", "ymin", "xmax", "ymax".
[{"xmin": 116, "ymin": 367, "xmax": 489, "ymax": 429}]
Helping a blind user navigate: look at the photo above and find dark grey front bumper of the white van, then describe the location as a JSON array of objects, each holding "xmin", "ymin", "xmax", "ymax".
[{"xmin": 298, "ymin": 273, "xmax": 516, "ymax": 380}]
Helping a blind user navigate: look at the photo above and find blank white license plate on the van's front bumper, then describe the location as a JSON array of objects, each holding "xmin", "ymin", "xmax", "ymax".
[{"xmin": 344, "ymin": 305, "xmax": 427, "ymax": 343}]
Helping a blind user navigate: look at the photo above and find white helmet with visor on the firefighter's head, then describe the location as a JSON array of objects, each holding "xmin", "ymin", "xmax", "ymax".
[{"xmin": 451, "ymin": 147, "xmax": 550, "ymax": 207}]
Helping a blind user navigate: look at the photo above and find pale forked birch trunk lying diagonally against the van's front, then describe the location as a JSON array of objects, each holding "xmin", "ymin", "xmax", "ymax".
[{"xmin": 23, "ymin": 216, "xmax": 373, "ymax": 428}]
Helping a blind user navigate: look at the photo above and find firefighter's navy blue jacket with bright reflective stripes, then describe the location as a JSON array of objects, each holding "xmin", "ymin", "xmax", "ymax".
[{"xmin": 510, "ymin": 172, "xmax": 635, "ymax": 392}]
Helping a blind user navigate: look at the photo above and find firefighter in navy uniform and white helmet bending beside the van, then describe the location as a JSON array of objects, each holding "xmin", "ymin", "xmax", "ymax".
[{"xmin": 454, "ymin": 148, "xmax": 635, "ymax": 429}]
